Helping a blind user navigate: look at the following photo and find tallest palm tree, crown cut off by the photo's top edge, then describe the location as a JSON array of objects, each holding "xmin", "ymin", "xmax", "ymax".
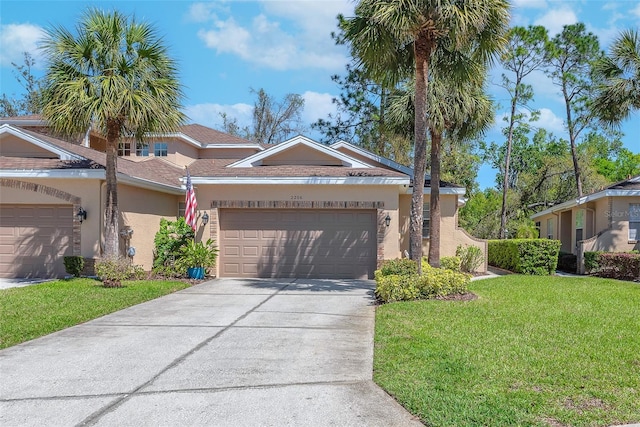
[{"xmin": 338, "ymin": 0, "xmax": 509, "ymax": 271}]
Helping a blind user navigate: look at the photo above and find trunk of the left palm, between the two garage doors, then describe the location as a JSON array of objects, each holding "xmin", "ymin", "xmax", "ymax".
[{"xmin": 104, "ymin": 120, "xmax": 120, "ymax": 257}]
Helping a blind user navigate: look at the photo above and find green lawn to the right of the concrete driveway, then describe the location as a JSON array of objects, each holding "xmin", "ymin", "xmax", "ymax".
[{"xmin": 374, "ymin": 275, "xmax": 640, "ymax": 426}]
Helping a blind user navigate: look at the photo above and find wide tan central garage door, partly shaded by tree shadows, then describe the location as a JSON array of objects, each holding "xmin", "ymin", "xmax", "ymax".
[{"xmin": 219, "ymin": 209, "xmax": 377, "ymax": 279}]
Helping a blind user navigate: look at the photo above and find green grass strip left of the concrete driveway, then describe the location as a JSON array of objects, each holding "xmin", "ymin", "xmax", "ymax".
[{"xmin": 0, "ymin": 279, "xmax": 190, "ymax": 348}]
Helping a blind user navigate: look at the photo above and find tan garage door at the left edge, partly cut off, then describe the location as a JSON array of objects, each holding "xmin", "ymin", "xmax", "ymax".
[{"xmin": 0, "ymin": 205, "xmax": 73, "ymax": 278}]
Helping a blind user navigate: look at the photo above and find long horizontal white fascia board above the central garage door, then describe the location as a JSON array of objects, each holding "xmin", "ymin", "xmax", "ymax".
[{"xmin": 188, "ymin": 176, "xmax": 409, "ymax": 185}]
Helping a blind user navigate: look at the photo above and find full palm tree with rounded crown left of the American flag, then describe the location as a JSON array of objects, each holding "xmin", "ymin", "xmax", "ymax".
[{"xmin": 42, "ymin": 9, "xmax": 185, "ymax": 257}]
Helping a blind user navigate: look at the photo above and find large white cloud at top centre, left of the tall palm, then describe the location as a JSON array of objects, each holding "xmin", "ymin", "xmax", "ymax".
[{"xmin": 193, "ymin": 1, "xmax": 353, "ymax": 70}]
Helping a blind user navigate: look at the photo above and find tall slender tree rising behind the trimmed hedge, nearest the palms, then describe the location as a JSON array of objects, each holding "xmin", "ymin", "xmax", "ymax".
[{"xmin": 500, "ymin": 26, "xmax": 547, "ymax": 239}]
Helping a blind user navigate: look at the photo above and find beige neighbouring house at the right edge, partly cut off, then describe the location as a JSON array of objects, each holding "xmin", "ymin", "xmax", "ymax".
[{"xmin": 531, "ymin": 175, "xmax": 640, "ymax": 273}]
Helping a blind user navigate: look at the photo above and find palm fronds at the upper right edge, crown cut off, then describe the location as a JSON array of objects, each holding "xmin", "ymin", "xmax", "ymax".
[{"xmin": 591, "ymin": 29, "xmax": 640, "ymax": 125}]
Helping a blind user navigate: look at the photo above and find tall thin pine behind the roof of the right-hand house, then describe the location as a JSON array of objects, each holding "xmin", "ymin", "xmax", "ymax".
[{"xmin": 546, "ymin": 23, "xmax": 602, "ymax": 197}]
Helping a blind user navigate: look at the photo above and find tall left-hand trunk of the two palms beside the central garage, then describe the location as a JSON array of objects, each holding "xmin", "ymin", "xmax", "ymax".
[{"xmin": 409, "ymin": 35, "xmax": 431, "ymax": 274}]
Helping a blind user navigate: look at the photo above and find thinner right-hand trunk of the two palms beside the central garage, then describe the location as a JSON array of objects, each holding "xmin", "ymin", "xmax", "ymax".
[{"xmin": 429, "ymin": 129, "xmax": 442, "ymax": 268}]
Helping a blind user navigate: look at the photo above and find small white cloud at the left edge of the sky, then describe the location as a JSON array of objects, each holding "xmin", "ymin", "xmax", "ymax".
[{"xmin": 0, "ymin": 24, "xmax": 44, "ymax": 67}]
